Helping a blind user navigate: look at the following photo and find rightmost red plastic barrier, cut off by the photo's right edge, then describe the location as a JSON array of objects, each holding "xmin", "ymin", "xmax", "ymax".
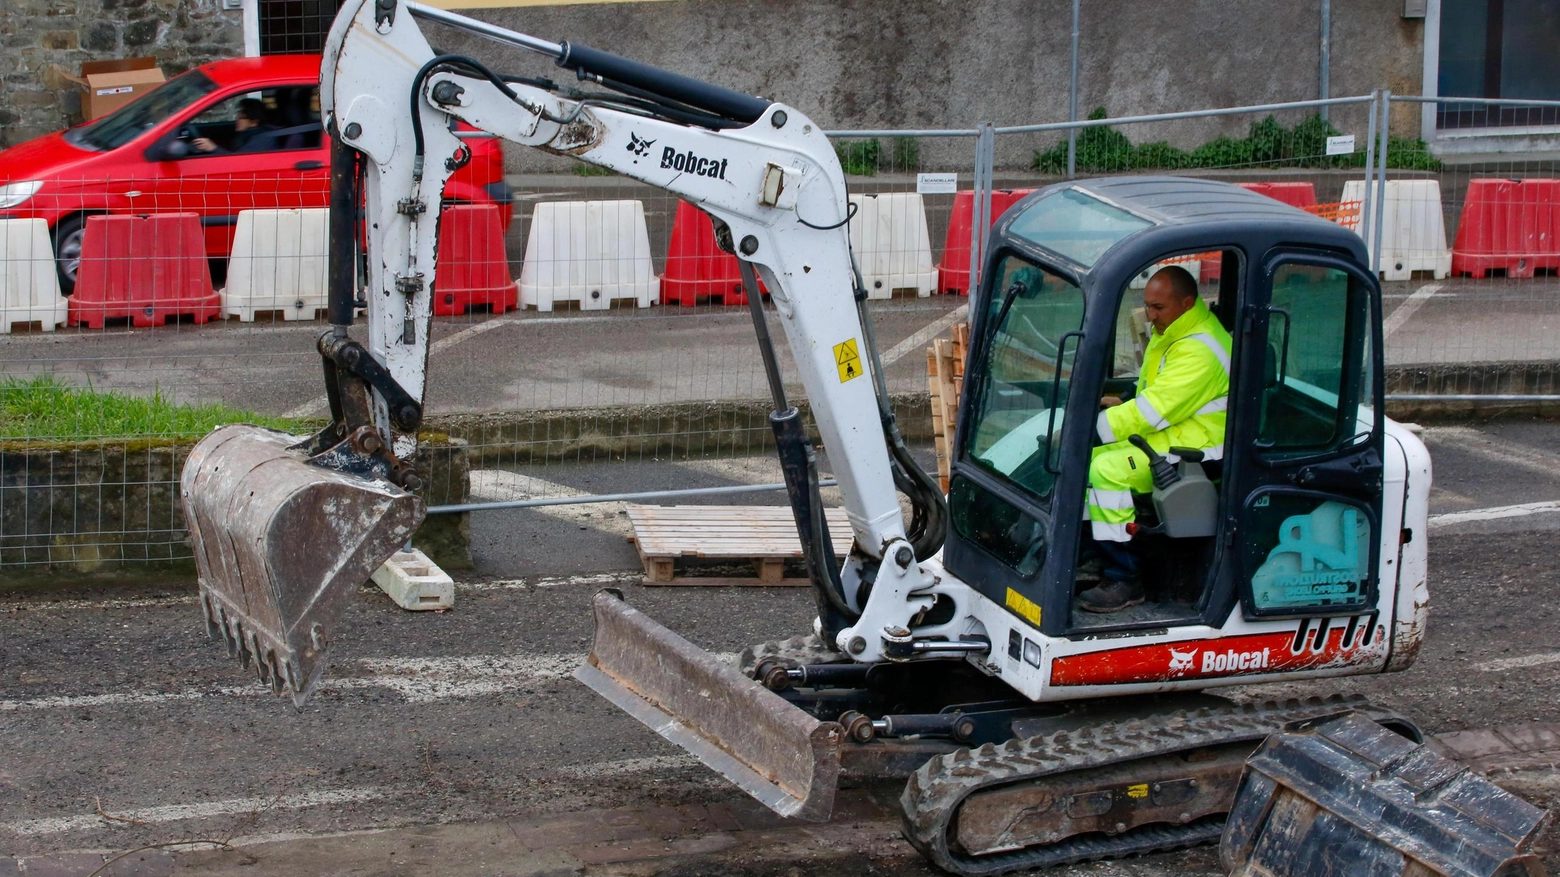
[{"xmin": 1452, "ymin": 179, "xmax": 1560, "ymax": 278}]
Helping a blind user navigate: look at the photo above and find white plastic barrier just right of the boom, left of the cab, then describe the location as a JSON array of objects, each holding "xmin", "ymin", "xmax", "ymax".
[{"xmin": 850, "ymin": 192, "xmax": 938, "ymax": 298}]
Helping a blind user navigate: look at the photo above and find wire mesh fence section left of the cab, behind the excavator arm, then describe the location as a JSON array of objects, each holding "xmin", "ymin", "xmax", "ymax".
[{"xmin": 0, "ymin": 127, "xmax": 970, "ymax": 566}]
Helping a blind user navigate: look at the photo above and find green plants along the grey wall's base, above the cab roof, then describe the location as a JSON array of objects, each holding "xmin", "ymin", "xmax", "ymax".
[{"xmin": 1031, "ymin": 106, "xmax": 1441, "ymax": 173}]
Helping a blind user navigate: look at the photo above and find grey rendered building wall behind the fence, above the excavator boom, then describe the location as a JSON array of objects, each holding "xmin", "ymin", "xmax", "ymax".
[{"xmin": 436, "ymin": 0, "xmax": 1424, "ymax": 172}]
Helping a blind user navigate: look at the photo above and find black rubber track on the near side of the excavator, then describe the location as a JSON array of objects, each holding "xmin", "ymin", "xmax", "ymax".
[{"xmin": 900, "ymin": 696, "xmax": 1390, "ymax": 877}]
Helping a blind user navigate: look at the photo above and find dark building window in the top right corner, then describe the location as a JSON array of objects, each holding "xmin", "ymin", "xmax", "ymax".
[{"xmin": 1435, "ymin": 0, "xmax": 1560, "ymax": 128}]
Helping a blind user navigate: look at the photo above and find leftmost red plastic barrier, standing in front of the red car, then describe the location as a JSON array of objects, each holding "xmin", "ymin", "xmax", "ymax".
[{"xmin": 70, "ymin": 214, "xmax": 222, "ymax": 329}]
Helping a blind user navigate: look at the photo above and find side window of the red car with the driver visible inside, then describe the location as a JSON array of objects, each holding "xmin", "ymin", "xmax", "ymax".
[{"xmin": 186, "ymin": 84, "xmax": 324, "ymax": 159}]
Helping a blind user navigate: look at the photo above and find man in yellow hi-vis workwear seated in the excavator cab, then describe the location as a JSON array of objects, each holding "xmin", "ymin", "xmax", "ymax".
[{"xmin": 1078, "ymin": 265, "xmax": 1229, "ymax": 612}]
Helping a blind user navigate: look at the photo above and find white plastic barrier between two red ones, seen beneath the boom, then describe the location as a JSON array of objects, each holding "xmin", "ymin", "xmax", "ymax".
[{"xmin": 519, "ymin": 201, "xmax": 661, "ymax": 311}]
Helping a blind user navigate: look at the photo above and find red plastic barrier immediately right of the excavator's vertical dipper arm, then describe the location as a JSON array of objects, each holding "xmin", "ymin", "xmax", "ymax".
[{"xmin": 434, "ymin": 204, "xmax": 519, "ymax": 317}]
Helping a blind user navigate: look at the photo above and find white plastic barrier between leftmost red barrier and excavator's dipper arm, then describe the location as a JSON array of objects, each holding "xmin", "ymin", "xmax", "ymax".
[{"xmin": 223, "ymin": 208, "xmax": 331, "ymax": 323}]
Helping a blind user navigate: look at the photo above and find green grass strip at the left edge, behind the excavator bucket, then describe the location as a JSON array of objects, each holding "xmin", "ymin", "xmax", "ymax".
[{"xmin": 0, "ymin": 375, "xmax": 307, "ymax": 442}]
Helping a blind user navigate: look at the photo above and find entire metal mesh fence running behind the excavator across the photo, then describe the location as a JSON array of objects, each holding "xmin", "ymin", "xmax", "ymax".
[{"xmin": 9, "ymin": 86, "xmax": 1560, "ymax": 568}]
